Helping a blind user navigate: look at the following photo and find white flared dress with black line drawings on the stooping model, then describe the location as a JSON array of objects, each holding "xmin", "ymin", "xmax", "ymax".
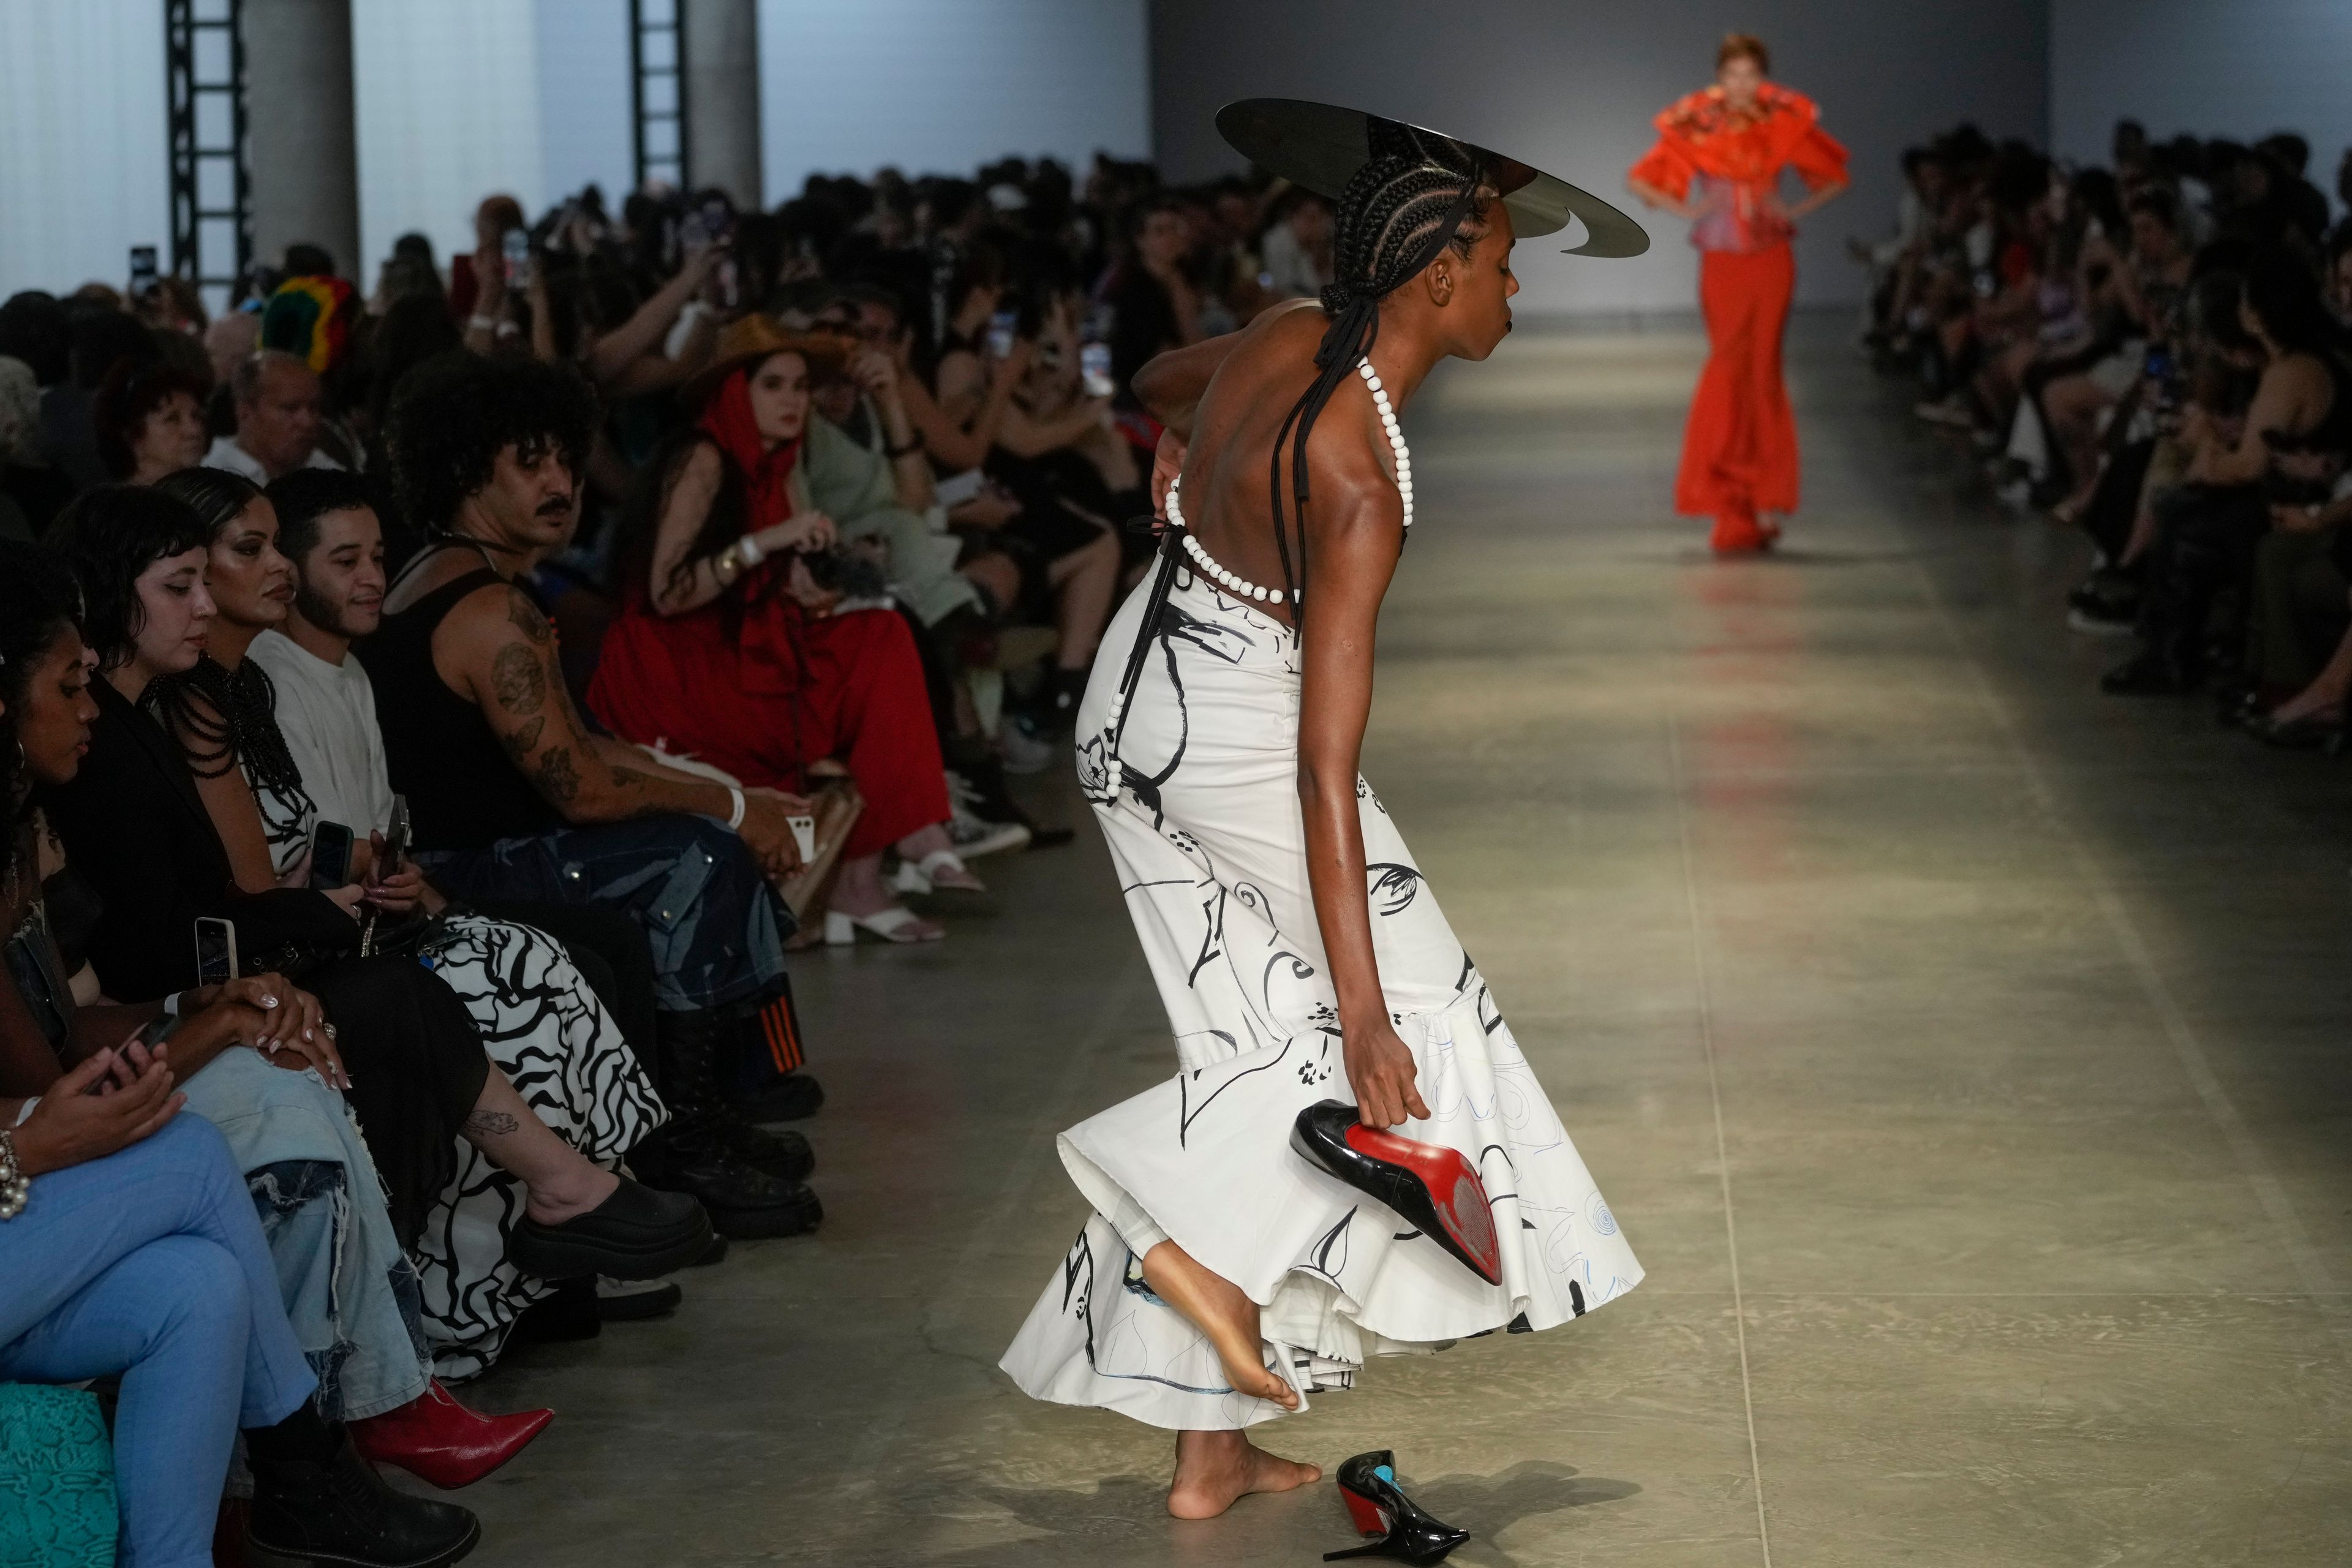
[{"xmin": 1002, "ymin": 569, "xmax": 1642, "ymax": 1430}]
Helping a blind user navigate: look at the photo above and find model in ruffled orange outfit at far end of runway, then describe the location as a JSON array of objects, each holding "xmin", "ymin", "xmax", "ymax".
[{"xmin": 1625, "ymin": 33, "xmax": 1846, "ymax": 552}]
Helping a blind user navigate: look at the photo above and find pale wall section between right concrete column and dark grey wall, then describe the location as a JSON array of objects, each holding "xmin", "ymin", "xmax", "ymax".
[{"xmin": 760, "ymin": 0, "xmax": 1153, "ymax": 205}]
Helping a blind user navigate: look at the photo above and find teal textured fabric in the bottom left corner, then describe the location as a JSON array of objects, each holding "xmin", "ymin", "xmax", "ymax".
[{"xmin": 0, "ymin": 1382, "xmax": 118, "ymax": 1568}]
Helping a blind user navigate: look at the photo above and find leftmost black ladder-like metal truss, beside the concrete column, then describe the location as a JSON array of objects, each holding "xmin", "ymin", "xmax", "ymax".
[{"xmin": 162, "ymin": 0, "xmax": 254, "ymax": 308}]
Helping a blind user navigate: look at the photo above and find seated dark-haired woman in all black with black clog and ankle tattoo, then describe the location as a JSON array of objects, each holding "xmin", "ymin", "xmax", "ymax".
[{"xmin": 45, "ymin": 486, "xmax": 710, "ymax": 1325}]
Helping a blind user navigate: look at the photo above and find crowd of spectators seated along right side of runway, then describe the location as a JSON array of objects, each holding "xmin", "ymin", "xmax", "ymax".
[{"xmin": 1853, "ymin": 120, "xmax": 2352, "ymax": 752}]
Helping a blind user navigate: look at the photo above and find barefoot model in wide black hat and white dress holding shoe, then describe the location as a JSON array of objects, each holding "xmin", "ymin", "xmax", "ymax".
[{"xmin": 1005, "ymin": 101, "xmax": 1646, "ymax": 1518}]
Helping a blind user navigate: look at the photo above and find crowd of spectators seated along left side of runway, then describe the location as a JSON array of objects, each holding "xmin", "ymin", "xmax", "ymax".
[{"xmin": 0, "ymin": 157, "xmax": 1331, "ymax": 1566}]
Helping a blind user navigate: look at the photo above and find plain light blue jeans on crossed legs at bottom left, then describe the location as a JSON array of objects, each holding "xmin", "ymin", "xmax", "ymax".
[{"xmin": 0, "ymin": 1112, "xmax": 317, "ymax": 1568}]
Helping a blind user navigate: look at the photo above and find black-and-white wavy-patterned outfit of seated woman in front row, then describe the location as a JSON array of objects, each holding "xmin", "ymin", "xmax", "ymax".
[{"xmin": 247, "ymin": 774, "xmax": 670, "ymax": 1382}]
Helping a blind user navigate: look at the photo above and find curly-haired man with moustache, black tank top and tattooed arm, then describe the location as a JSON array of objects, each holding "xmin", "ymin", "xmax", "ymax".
[{"xmin": 358, "ymin": 355, "xmax": 842, "ymax": 1170}]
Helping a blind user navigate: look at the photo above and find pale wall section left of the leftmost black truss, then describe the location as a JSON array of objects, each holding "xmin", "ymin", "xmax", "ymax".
[{"xmin": 0, "ymin": 0, "xmax": 172, "ymax": 298}]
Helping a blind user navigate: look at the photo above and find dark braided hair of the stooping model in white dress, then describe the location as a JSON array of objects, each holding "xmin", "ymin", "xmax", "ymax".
[{"xmin": 1270, "ymin": 120, "xmax": 1489, "ymax": 637}]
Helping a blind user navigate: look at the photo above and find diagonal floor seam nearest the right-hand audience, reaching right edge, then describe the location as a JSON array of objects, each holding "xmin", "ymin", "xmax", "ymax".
[{"xmin": 1912, "ymin": 512, "xmax": 2338, "ymax": 1295}]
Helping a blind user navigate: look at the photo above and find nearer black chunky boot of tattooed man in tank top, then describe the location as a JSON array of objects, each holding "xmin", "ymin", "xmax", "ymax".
[{"xmin": 628, "ymin": 1013, "xmax": 826, "ymax": 1242}]
